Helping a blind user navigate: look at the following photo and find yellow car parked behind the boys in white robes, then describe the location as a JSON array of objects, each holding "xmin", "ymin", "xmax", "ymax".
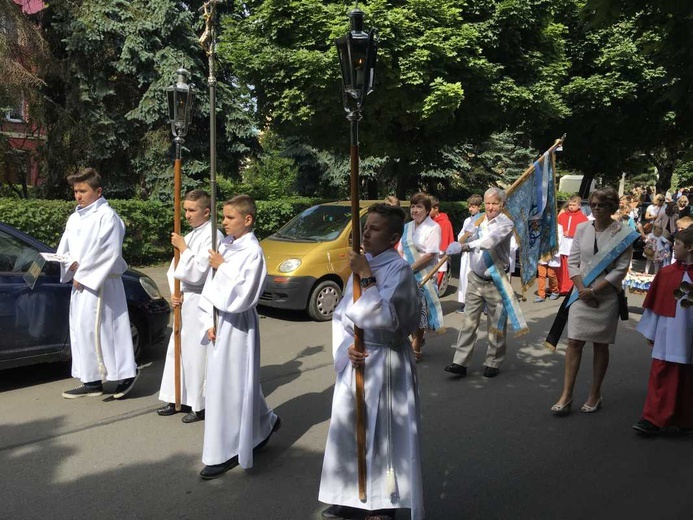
[{"xmin": 260, "ymin": 200, "xmax": 409, "ymax": 321}]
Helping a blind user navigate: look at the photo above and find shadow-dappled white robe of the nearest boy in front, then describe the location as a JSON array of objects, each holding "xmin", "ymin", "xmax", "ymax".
[{"xmin": 318, "ymin": 249, "xmax": 424, "ymax": 520}]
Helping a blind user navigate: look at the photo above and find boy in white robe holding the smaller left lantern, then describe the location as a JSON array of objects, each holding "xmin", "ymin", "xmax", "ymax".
[{"xmin": 156, "ymin": 190, "xmax": 224, "ymax": 423}]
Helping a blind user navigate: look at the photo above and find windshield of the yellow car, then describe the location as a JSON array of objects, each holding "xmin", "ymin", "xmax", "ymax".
[{"xmin": 273, "ymin": 206, "xmax": 351, "ymax": 242}]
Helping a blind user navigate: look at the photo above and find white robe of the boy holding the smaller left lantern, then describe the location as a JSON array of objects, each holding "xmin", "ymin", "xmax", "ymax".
[{"xmin": 159, "ymin": 221, "xmax": 224, "ymax": 412}]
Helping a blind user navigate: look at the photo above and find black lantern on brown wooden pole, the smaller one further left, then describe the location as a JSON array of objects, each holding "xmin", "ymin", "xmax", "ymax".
[{"xmin": 166, "ymin": 67, "xmax": 195, "ymax": 411}]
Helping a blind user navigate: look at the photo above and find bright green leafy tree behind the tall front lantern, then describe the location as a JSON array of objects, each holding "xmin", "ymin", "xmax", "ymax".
[{"xmin": 219, "ymin": 0, "xmax": 568, "ymax": 195}]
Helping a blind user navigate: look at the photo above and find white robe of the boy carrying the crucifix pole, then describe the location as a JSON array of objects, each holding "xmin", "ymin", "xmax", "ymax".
[{"xmin": 200, "ymin": 232, "xmax": 277, "ymax": 469}]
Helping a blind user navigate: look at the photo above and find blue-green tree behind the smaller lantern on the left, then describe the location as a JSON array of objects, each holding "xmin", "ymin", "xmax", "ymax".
[{"xmin": 35, "ymin": 0, "xmax": 256, "ymax": 200}]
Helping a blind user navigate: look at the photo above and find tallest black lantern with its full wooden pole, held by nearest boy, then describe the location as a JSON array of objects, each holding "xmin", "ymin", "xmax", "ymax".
[{"xmin": 335, "ymin": 3, "xmax": 377, "ymax": 501}]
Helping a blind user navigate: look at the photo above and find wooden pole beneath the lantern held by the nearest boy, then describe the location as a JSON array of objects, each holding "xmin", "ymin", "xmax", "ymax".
[{"xmin": 347, "ymin": 109, "xmax": 366, "ymax": 502}]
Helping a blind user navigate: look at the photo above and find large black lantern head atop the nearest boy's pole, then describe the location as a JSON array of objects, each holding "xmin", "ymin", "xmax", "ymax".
[{"xmin": 336, "ymin": 7, "xmax": 378, "ymax": 112}]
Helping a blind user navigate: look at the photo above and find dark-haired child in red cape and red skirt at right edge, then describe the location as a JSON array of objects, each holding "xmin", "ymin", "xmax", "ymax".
[{"xmin": 633, "ymin": 227, "xmax": 693, "ymax": 435}]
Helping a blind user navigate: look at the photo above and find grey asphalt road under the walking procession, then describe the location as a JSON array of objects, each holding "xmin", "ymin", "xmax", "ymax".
[{"xmin": 0, "ymin": 269, "xmax": 693, "ymax": 520}]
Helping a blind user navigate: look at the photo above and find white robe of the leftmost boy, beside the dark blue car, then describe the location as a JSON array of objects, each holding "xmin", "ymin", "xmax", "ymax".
[{"xmin": 58, "ymin": 197, "xmax": 137, "ymax": 383}]
